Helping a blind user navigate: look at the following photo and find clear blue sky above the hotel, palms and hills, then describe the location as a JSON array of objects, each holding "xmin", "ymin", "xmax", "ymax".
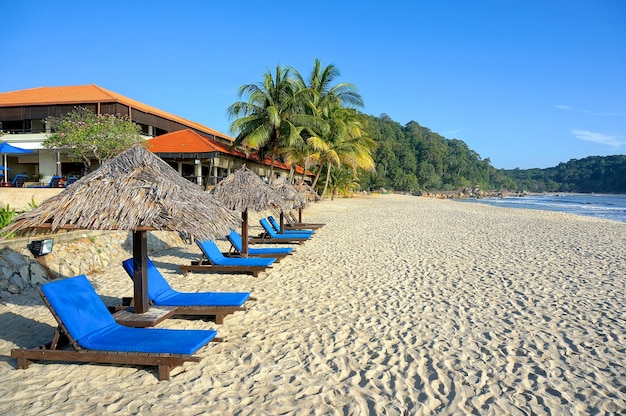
[{"xmin": 0, "ymin": 0, "xmax": 626, "ymax": 169}]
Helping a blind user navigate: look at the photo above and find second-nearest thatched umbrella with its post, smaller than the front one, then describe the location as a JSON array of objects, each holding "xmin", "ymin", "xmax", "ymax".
[{"xmin": 211, "ymin": 165, "xmax": 290, "ymax": 257}]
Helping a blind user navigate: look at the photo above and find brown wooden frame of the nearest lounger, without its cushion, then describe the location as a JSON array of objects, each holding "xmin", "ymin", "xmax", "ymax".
[{"xmin": 11, "ymin": 290, "xmax": 223, "ymax": 380}]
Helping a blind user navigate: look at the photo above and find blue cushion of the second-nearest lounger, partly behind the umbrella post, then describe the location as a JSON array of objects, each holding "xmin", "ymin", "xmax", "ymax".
[{"xmin": 122, "ymin": 258, "xmax": 250, "ymax": 306}]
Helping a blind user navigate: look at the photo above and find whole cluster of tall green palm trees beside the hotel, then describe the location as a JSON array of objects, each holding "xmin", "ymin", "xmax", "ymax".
[{"xmin": 227, "ymin": 59, "xmax": 375, "ymax": 200}]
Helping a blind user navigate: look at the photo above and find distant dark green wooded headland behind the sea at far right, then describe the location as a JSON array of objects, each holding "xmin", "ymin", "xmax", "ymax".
[{"xmin": 501, "ymin": 155, "xmax": 626, "ymax": 194}]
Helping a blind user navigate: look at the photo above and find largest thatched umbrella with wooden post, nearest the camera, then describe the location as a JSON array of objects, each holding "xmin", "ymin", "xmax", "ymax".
[{"xmin": 3, "ymin": 145, "xmax": 239, "ymax": 313}]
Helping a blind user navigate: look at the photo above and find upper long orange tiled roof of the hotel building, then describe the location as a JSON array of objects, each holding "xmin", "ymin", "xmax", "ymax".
[{"xmin": 0, "ymin": 84, "xmax": 234, "ymax": 142}]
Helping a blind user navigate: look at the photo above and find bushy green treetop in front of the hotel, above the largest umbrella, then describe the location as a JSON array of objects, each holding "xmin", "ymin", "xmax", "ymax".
[{"xmin": 43, "ymin": 108, "xmax": 143, "ymax": 167}]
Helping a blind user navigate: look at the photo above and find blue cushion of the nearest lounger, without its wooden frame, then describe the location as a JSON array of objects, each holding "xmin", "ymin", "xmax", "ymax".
[{"xmin": 41, "ymin": 275, "xmax": 217, "ymax": 355}]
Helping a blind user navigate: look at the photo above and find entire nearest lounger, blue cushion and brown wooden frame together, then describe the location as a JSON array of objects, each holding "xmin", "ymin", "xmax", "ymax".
[{"xmin": 11, "ymin": 275, "xmax": 221, "ymax": 380}]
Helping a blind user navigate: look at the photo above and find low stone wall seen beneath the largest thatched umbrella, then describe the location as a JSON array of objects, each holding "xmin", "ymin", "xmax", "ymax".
[{"xmin": 0, "ymin": 231, "xmax": 184, "ymax": 298}]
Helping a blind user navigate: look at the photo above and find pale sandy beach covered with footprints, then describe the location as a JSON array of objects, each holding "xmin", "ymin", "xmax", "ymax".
[{"xmin": 0, "ymin": 195, "xmax": 626, "ymax": 415}]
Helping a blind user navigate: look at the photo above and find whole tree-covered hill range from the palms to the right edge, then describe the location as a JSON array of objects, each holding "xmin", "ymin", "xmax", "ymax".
[{"xmin": 359, "ymin": 114, "xmax": 626, "ymax": 193}]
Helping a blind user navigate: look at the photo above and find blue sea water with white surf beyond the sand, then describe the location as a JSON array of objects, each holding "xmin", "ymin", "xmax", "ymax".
[{"xmin": 459, "ymin": 194, "xmax": 626, "ymax": 222}]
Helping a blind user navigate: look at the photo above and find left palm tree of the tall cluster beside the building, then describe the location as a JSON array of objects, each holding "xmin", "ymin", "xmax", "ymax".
[{"xmin": 227, "ymin": 65, "xmax": 303, "ymax": 182}]
